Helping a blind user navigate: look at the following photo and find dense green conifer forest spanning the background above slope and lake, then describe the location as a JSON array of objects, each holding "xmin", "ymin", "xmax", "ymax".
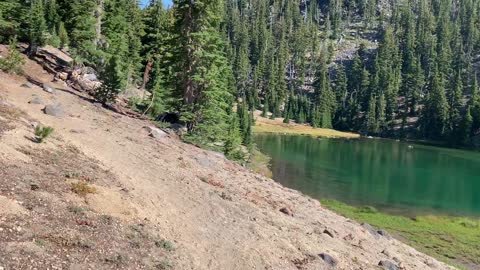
[{"xmin": 0, "ymin": 0, "xmax": 480, "ymax": 151}]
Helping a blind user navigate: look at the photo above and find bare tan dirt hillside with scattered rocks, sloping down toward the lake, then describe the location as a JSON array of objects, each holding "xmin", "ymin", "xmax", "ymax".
[{"xmin": 0, "ymin": 53, "xmax": 449, "ymax": 270}]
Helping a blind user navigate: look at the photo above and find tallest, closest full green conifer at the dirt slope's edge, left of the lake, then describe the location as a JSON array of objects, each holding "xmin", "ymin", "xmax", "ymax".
[{"xmin": 174, "ymin": 0, "xmax": 239, "ymax": 144}]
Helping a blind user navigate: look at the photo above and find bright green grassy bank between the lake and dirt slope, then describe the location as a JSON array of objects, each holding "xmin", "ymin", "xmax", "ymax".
[{"xmin": 321, "ymin": 200, "xmax": 480, "ymax": 269}]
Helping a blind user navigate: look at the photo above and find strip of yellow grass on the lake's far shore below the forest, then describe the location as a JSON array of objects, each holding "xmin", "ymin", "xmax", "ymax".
[{"xmin": 253, "ymin": 116, "xmax": 360, "ymax": 138}]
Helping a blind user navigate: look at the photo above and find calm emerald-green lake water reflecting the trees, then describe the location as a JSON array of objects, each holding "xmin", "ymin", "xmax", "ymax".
[{"xmin": 255, "ymin": 135, "xmax": 480, "ymax": 216}]
